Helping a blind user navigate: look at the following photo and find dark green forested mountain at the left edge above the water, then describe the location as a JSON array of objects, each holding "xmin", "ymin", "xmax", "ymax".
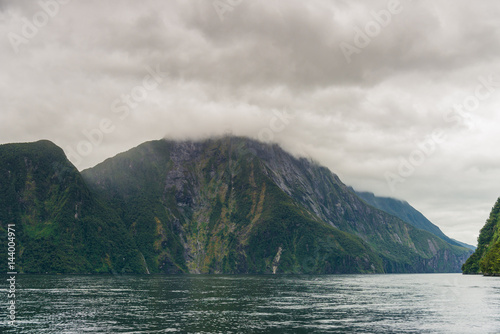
[{"xmin": 0, "ymin": 141, "xmax": 144, "ymax": 273}]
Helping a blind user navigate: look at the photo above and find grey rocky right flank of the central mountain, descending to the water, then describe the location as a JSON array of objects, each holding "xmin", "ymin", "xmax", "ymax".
[{"xmin": 240, "ymin": 140, "xmax": 470, "ymax": 272}]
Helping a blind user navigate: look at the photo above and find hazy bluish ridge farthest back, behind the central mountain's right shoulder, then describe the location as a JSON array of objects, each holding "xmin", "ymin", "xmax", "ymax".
[{"xmin": 350, "ymin": 188, "xmax": 476, "ymax": 251}]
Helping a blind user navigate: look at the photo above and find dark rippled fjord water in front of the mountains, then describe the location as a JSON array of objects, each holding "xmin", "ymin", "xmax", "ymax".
[{"xmin": 0, "ymin": 274, "xmax": 500, "ymax": 334}]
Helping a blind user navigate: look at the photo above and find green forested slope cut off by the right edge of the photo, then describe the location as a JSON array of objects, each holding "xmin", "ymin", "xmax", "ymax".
[{"xmin": 462, "ymin": 198, "xmax": 500, "ymax": 276}]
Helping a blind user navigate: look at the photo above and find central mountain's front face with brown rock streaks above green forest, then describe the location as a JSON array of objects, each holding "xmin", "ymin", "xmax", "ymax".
[{"xmin": 83, "ymin": 140, "xmax": 383, "ymax": 273}]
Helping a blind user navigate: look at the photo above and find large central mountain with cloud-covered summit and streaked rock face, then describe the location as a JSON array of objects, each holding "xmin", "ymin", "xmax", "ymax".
[{"xmin": 82, "ymin": 137, "xmax": 469, "ymax": 273}]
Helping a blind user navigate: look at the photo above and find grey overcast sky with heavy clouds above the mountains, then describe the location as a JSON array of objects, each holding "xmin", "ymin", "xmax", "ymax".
[{"xmin": 0, "ymin": 0, "xmax": 500, "ymax": 244}]
